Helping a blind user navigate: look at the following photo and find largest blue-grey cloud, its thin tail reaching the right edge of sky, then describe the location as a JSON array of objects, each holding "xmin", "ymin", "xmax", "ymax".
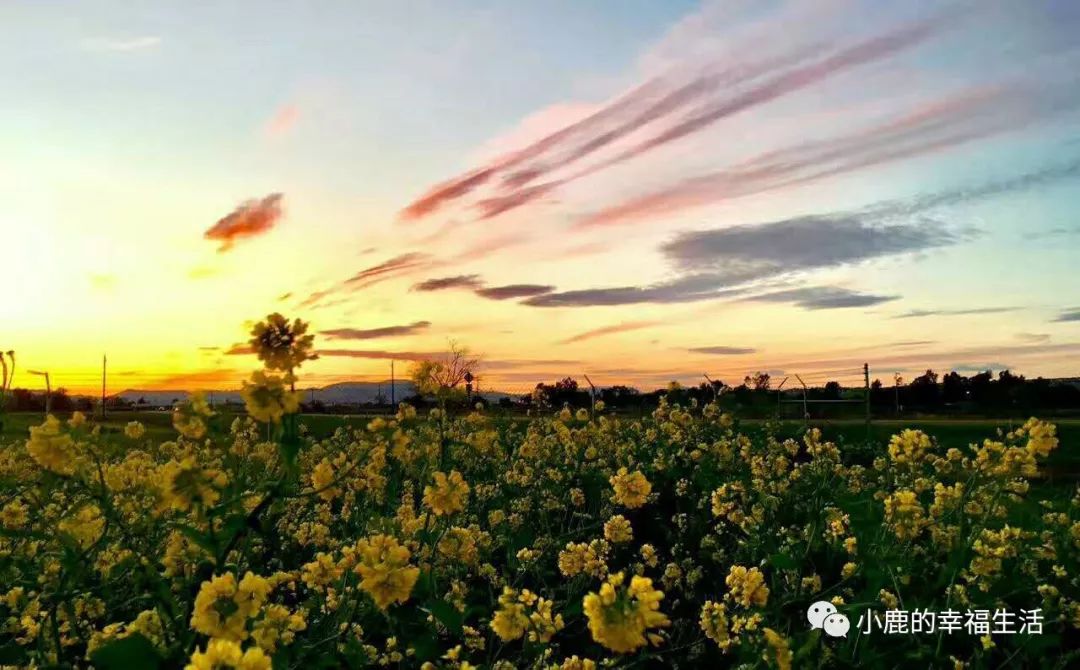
[{"xmin": 525, "ymin": 160, "xmax": 1080, "ymax": 309}]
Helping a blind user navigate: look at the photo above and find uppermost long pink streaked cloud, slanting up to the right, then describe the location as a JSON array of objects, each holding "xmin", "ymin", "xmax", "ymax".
[{"xmin": 401, "ymin": 14, "xmax": 956, "ymax": 220}]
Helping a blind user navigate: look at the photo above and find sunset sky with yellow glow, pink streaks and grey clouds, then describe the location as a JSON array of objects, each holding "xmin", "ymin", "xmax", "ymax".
[{"xmin": 0, "ymin": 0, "xmax": 1080, "ymax": 391}]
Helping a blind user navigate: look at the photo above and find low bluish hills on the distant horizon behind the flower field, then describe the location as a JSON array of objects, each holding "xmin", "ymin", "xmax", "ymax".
[{"xmin": 113, "ymin": 380, "xmax": 511, "ymax": 407}]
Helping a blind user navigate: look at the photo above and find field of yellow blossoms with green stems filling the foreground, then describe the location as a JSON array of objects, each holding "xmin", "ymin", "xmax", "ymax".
[{"xmin": 0, "ymin": 318, "xmax": 1080, "ymax": 670}]
